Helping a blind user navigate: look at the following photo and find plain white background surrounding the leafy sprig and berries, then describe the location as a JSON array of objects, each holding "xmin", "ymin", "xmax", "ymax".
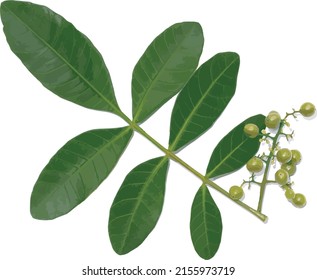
[{"xmin": 0, "ymin": 0, "xmax": 317, "ymax": 280}]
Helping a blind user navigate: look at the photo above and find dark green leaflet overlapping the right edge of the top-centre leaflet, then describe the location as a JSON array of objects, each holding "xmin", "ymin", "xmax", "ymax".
[{"xmin": 169, "ymin": 52, "xmax": 240, "ymax": 151}]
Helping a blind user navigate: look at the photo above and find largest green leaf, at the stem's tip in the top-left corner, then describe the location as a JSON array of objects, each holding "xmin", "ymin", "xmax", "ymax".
[{"xmin": 1, "ymin": 1, "xmax": 120, "ymax": 114}]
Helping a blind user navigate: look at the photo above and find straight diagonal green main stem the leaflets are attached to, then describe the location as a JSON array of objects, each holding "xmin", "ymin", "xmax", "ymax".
[{"xmin": 120, "ymin": 112, "xmax": 267, "ymax": 222}]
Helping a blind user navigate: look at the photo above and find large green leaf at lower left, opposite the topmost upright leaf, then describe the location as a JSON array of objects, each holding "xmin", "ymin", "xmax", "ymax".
[{"xmin": 31, "ymin": 127, "xmax": 133, "ymax": 220}]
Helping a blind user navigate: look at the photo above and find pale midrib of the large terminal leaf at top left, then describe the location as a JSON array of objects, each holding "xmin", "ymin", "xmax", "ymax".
[{"xmin": 4, "ymin": 6, "xmax": 122, "ymax": 116}]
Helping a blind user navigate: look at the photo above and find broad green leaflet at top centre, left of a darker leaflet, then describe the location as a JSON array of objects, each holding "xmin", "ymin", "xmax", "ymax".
[{"xmin": 132, "ymin": 22, "xmax": 204, "ymax": 123}]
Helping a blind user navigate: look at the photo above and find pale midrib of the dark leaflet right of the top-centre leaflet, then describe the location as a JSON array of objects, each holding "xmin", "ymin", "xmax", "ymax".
[{"xmin": 169, "ymin": 58, "xmax": 238, "ymax": 151}]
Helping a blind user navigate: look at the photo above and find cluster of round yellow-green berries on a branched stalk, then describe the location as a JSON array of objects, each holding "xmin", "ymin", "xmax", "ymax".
[{"xmin": 229, "ymin": 102, "xmax": 316, "ymax": 211}]
